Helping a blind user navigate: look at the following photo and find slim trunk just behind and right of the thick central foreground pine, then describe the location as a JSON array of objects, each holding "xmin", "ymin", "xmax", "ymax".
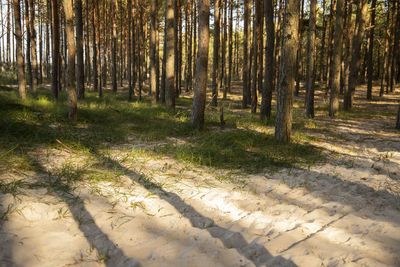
[{"xmin": 211, "ymin": 0, "xmax": 221, "ymax": 107}]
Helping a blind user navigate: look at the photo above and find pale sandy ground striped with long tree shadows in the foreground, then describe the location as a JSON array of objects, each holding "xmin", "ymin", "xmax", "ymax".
[{"xmin": 0, "ymin": 90, "xmax": 400, "ymax": 267}]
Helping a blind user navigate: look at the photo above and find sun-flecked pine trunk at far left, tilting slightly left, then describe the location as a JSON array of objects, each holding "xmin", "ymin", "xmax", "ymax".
[{"xmin": 13, "ymin": 0, "xmax": 26, "ymax": 99}]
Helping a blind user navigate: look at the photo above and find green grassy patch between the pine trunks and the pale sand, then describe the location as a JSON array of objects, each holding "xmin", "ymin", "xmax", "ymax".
[{"xmin": 0, "ymin": 80, "xmax": 323, "ymax": 187}]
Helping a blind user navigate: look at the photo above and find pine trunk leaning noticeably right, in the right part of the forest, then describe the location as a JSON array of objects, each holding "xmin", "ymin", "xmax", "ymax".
[{"xmin": 344, "ymin": 0, "xmax": 368, "ymax": 110}]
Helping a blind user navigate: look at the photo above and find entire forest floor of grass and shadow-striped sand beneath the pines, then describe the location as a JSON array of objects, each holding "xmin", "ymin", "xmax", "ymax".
[{"xmin": 0, "ymin": 77, "xmax": 400, "ymax": 266}]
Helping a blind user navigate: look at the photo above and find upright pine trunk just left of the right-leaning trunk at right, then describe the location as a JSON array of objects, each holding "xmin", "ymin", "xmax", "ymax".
[{"xmin": 329, "ymin": 0, "xmax": 344, "ymax": 117}]
